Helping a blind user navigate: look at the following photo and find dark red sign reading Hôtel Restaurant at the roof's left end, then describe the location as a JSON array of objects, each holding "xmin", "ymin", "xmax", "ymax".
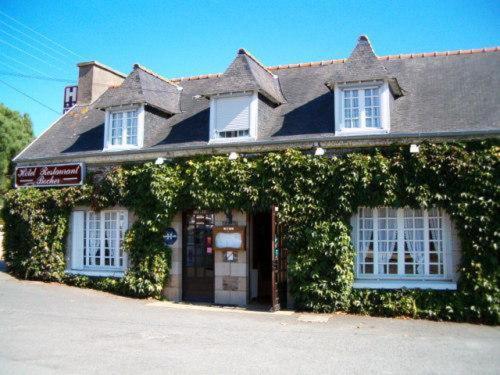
[{"xmin": 15, "ymin": 163, "xmax": 84, "ymax": 188}]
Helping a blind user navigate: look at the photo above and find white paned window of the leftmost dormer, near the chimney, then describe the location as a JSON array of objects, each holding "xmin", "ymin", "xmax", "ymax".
[{"xmin": 104, "ymin": 107, "xmax": 144, "ymax": 150}]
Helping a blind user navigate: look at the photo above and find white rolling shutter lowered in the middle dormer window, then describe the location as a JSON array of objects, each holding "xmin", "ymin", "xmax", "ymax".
[{"xmin": 215, "ymin": 96, "xmax": 252, "ymax": 132}]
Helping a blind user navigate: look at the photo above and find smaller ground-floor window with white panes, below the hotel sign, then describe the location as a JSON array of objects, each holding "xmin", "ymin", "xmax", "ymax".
[{"xmin": 71, "ymin": 210, "xmax": 127, "ymax": 273}]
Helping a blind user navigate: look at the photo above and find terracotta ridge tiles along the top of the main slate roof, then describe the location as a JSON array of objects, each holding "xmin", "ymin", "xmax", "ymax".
[{"xmin": 172, "ymin": 46, "xmax": 500, "ymax": 82}]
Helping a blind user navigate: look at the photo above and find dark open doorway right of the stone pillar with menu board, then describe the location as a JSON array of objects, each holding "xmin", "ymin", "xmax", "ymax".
[{"xmin": 251, "ymin": 211, "xmax": 272, "ymax": 306}]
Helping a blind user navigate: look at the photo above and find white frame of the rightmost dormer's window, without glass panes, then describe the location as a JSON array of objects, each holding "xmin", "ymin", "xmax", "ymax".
[{"xmin": 334, "ymin": 81, "xmax": 391, "ymax": 136}]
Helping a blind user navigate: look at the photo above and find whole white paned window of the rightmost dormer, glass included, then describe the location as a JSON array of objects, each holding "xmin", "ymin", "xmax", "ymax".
[{"xmin": 335, "ymin": 83, "xmax": 390, "ymax": 135}]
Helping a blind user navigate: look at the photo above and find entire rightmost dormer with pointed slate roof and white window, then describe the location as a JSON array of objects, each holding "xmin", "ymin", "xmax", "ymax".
[{"xmin": 326, "ymin": 35, "xmax": 403, "ymax": 135}]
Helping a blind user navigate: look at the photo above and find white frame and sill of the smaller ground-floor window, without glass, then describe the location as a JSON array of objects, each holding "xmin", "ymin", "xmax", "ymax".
[{"xmin": 67, "ymin": 208, "xmax": 129, "ymax": 277}]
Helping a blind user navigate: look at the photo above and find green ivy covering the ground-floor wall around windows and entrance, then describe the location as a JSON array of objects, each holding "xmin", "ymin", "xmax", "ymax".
[{"xmin": 3, "ymin": 140, "xmax": 500, "ymax": 324}]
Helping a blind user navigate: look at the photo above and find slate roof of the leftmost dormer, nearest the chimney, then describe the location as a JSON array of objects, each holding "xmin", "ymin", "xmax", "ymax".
[{"xmin": 95, "ymin": 64, "xmax": 182, "ymax": 114}]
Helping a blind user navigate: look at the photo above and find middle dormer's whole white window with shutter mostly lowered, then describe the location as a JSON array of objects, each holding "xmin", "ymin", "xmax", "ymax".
[{"xmin": 210, "ymin": 93, "xmax": 257, "ymax": 142}]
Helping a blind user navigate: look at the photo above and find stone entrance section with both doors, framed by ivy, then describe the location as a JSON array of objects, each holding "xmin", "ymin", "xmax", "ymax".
[{"xmin": 163, "ymin": 210, "xmax": 286, "ymax": 308}]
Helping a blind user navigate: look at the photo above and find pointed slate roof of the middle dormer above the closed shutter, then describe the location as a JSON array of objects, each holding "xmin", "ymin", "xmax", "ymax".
[{"xmin": 204, "ymin": 48, "xmax": 285, "ymax": 104}]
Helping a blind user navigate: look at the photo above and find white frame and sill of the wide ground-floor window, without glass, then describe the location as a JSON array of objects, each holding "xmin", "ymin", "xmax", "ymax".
[{"xmin": 351, "ymin": 207, "xmax": 457, "ymax": 290}]
